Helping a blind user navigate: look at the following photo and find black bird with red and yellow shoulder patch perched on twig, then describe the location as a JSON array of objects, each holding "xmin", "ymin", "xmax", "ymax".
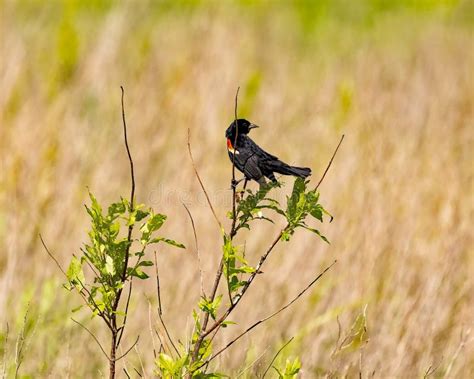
[{"xmin": 225, "ymin": 119, "xmax": 311, "ymax": 187}]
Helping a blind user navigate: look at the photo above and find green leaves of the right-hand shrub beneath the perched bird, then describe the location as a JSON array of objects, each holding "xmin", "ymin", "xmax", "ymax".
[{"xmin": 183, "ymin": 178, "xmax": 329, "ymax": 379}]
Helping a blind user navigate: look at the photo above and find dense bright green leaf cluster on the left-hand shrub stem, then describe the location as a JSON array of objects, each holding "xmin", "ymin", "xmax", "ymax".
[{"xmin": 66, "ymin": 193, "xmax": 184, "ymax": 315}]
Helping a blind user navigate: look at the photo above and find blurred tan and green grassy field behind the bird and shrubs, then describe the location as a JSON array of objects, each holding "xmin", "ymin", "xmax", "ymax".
[{"xmin": 0, "ymin": 0, "xmax": 474, "ymax": 378}]
